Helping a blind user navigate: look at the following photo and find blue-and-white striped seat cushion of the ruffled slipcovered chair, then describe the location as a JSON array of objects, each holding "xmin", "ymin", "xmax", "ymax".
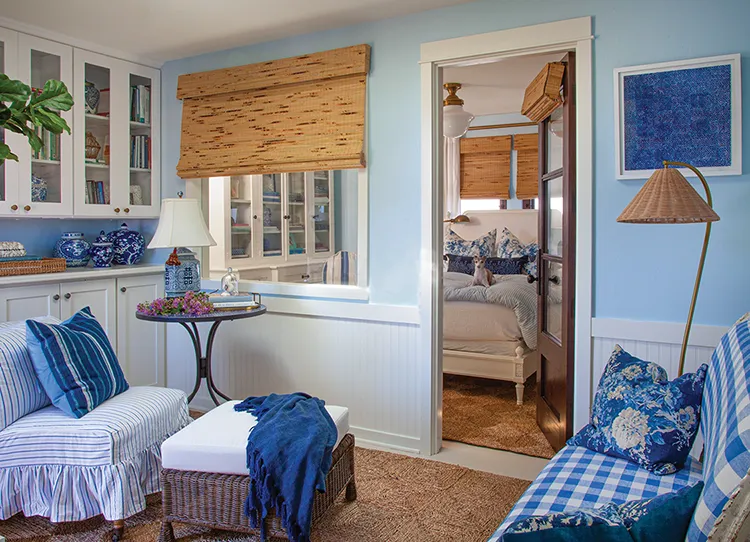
[{"xmin": 0, "ymin": 386, "xmax": 188, "ymax": 468}]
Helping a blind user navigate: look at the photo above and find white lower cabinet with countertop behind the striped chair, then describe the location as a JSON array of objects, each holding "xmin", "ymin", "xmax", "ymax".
[{"xmin": 0, "ymin": 274, "xmax": 166, "ymax": 386}]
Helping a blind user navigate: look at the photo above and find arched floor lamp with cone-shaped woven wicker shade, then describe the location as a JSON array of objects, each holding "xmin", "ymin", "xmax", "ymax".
[{"xmin": 617, "ymin": 161, "xmax": 719, "ymax": 376}]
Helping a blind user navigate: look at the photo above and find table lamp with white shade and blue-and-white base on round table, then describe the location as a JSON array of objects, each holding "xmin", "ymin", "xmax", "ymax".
[{"xmin": 148, "ymin": 192, "xmax": 216, "ymax": 297}]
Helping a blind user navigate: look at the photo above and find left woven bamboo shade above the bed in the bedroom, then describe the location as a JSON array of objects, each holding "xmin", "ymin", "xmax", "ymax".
[{"xmin": 461, "ymin": 136, "xmax": 511, "ymax": 199}]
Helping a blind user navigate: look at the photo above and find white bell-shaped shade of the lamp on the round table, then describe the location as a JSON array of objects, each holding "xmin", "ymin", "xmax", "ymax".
[{"xmin": 148, "ymin": 198, "xmax": 216, "ymax": 248}]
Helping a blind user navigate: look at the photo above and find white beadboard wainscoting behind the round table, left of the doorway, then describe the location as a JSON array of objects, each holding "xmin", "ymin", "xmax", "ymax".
[{"xmin": 167, "ymin": 306, "xmax": 428, "ymax": 453}]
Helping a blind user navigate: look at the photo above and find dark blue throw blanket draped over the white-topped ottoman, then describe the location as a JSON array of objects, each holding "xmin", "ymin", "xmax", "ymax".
[{"xmin": 234, "ymin": 393, "xmax": 337, "ymax": 542}]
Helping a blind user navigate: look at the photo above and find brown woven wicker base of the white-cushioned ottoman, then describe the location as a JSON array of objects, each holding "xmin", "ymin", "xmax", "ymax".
[{"xmin": 159, "ymin": 433, "xmax": 357, "ymax": 542}]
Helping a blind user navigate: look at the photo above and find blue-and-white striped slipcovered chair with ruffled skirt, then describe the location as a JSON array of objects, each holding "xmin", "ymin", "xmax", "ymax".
[{"xmin": 0, "ymin": 319, "xmax": 190, "ymax": 540}]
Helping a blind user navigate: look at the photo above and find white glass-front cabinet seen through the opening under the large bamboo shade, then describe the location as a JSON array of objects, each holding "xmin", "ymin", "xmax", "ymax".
[{"xmin": 209, "ymin": 171, "xmax": 335, "ymax": 282}]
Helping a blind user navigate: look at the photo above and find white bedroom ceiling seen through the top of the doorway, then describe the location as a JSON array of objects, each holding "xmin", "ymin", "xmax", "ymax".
[{"xmin": 443, "ymin": 53, "xmax": 564, "ymax": 116}]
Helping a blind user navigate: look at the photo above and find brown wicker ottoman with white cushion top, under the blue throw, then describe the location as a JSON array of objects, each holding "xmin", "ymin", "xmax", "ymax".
[{"xmin": 159, "ymin": 401, "xmax": 357, "ymax": 542}]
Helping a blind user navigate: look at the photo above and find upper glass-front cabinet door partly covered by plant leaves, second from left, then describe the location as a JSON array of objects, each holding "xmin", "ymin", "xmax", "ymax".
[{"xmin": 14, "ymin": 34, "xmax": 73, "ymax": 216}]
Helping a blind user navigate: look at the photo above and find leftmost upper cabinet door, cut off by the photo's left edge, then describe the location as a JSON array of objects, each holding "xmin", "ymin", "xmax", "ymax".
[{"xmin": 0, "ymin": 28, "xmax": 18, "ymax": 216}]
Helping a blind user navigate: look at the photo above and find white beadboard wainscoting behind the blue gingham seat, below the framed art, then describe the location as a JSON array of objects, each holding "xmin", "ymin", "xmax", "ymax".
[{"xmin": 591, "ymin": 318, "xmax": 728, "ymax": 384}]
